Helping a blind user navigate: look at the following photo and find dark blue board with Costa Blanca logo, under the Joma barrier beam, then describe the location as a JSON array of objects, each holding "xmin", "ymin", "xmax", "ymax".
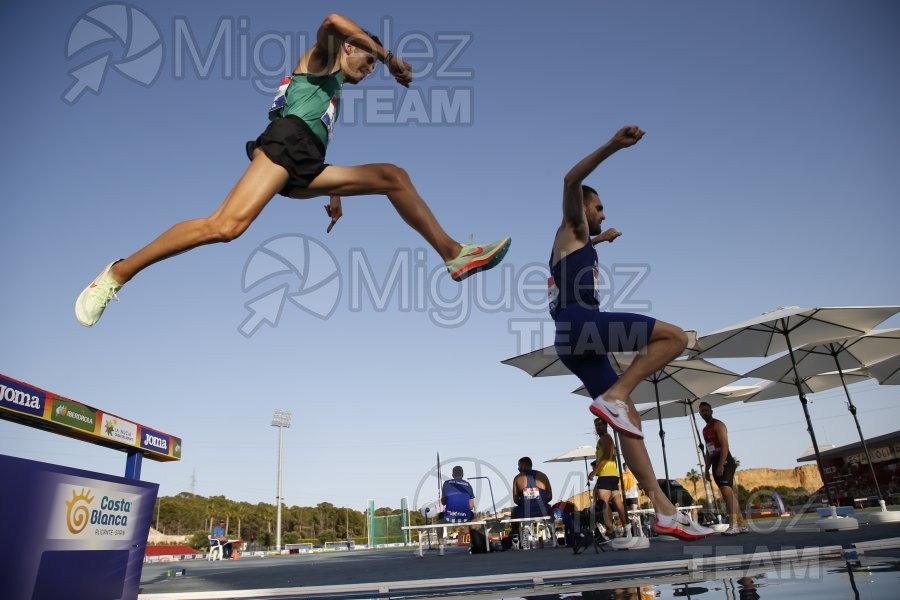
[{"xmin": 0, "ymin": 454, "xmax": 159, "ymax": 600}]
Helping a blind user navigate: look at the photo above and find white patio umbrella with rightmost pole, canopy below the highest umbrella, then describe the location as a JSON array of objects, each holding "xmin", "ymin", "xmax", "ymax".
[{"xmin": 746, "ymin": 329, "xmax": 900, "ymax": 510}]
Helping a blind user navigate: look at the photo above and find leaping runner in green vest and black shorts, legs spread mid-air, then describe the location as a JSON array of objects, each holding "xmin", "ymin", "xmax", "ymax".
[{"xmin": 75, "ymin": 14, "xmax": 510, "ymax": 327}]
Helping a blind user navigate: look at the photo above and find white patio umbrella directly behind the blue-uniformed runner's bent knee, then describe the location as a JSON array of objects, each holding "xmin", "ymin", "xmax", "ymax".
[{"xmin": 574, "ymin": 358, "xmax": 740, "ymax": 495}]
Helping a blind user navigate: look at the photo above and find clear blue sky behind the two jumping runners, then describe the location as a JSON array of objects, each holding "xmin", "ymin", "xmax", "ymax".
[{"xmin": 0, "ymin": 0, "xmax": 900, "ymax": 509}]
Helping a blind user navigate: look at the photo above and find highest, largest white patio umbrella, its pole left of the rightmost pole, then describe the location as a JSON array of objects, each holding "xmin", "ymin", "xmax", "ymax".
[{"xmin": 697, "ymin": 306, "xmax": 900, "ymax": 505}]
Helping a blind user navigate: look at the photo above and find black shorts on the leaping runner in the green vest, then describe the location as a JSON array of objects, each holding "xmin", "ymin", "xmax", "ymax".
[{"xmin": 247, "ymin": 116, "xmax": 328, "ymax": 197}]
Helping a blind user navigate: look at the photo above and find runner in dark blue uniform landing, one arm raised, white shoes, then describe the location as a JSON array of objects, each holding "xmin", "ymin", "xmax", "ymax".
[{"xmin": 548, "ymin": 125, "xmax": 714, "ymax": 539}]
